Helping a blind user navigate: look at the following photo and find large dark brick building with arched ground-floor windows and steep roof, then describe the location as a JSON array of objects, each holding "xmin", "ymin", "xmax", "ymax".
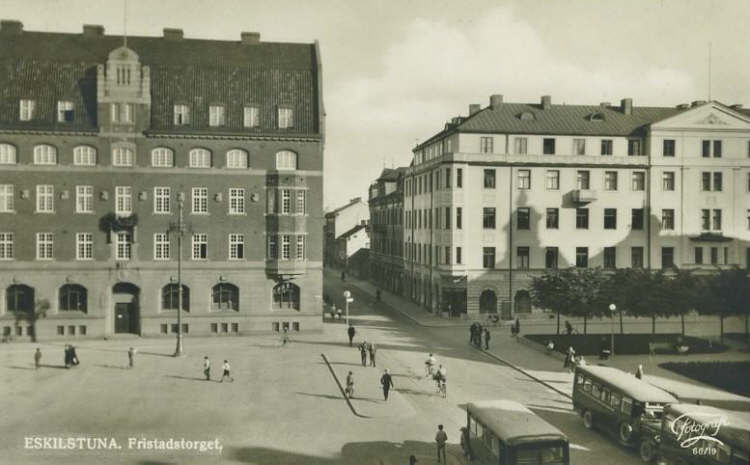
[{"xmin": 0, "ymin": 21, "xmax": 324, "ymax": 339}]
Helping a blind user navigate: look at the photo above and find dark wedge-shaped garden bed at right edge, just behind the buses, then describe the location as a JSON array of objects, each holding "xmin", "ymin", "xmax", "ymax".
[{"xmin": 659, "ymin": 362, "xmax": 750, "ymax": 397}]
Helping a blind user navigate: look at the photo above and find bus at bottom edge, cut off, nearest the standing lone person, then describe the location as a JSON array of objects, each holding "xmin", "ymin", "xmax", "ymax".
[{"xmin": 466, "ymin": 400, "xmax": 570, "ymax": 465}]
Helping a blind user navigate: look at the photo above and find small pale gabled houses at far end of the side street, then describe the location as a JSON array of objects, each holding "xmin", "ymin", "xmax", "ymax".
[{"xmin": 323, "ymin": 197, "xmax": 370, "ymax": 270}]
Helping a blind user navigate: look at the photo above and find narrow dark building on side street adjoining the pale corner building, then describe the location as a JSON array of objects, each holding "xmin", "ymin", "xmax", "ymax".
[{"xmin": 369, "ymin": 167, "xmax": 408, "ymax": 295}]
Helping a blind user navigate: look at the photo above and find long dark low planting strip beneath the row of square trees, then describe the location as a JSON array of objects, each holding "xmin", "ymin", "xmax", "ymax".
[{"xmin": 524, "ymin": 334, "xmax": 727, "ymax": 356}]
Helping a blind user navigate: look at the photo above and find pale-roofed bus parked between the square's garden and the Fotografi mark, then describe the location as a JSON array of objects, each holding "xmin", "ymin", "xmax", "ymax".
[{"xmin": 573, "ymin": 366, "xmax": 677, "ymax": 445}]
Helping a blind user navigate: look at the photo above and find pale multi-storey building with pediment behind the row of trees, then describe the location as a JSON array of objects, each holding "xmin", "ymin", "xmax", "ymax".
[{"xmin": 404, "ymin": 95, "xmax": 750, "ymax": 318}]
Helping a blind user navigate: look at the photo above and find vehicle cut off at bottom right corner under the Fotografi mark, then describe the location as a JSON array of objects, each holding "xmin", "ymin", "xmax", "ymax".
[{"xmin": 640, "ymin": 404, "xmax": 750, "ymax": 465}]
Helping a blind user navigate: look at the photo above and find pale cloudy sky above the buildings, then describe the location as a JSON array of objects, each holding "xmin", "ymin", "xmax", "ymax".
[{"xmin": 0, "ymin": 0, "xmax": 750, "ymax": 210}]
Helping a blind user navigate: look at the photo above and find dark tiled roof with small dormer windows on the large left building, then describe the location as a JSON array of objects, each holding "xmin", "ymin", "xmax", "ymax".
[{"xmin": 0, "ymin": 26, "xmax": 319, "ymax": 134}]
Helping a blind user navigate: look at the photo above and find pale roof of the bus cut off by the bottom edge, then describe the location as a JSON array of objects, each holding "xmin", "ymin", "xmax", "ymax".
[{"xmin": 466, "ymin": 399, "xmax": 568, "ymax": 445}]
